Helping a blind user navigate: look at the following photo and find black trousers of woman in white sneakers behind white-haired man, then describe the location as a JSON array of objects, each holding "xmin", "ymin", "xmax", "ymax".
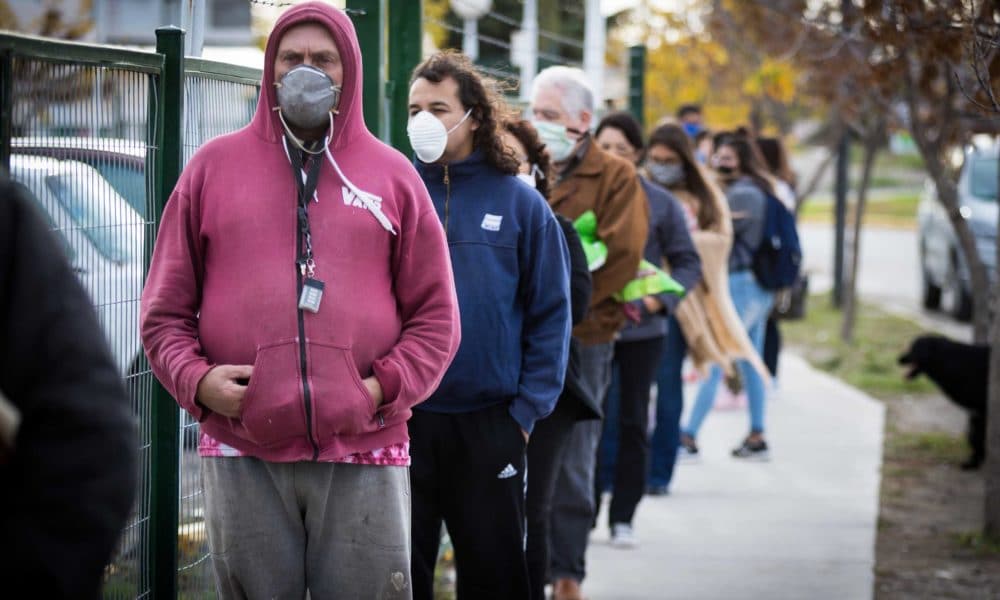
[{"xmin": 594, "ymin": 336, "xmax": 665, "ymax": 525}]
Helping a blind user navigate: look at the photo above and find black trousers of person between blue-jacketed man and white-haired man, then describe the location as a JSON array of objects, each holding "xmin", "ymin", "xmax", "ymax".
[{"xmin": 526, "ymin": 394, "xmax": 579, "ymax": 600}]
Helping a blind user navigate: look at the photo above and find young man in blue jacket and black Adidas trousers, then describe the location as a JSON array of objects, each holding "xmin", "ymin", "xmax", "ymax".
[{"xmin": 408, "ymin": 52, "xmax": 570, "ymax": 600}]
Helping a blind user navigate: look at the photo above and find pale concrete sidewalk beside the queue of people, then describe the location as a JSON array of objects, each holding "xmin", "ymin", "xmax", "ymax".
[{"xmin": 584, "ymin": 353, "xmax": 884, "ymax": 600}]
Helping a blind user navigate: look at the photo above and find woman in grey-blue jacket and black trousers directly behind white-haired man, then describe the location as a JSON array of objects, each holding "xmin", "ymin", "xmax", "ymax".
[{"xmin": 594, "ymin": 112, "xmax": 701, "ymax": 547}]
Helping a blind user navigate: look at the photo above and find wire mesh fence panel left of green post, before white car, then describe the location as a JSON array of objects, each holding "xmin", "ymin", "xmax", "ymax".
[{"xmin": 8, "ymin": 49, "xmax": 156, "ymax": 598}]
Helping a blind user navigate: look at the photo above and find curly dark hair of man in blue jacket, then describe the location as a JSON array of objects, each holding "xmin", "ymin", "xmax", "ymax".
[{"xmin": 410, "ymin": 50, "xmax": 518, "ymax": 175}]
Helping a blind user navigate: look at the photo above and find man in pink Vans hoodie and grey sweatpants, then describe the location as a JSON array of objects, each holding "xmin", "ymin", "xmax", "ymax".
[{"xmin": 141, "ymin": 2, "xmax": 459, "ymax": 598}]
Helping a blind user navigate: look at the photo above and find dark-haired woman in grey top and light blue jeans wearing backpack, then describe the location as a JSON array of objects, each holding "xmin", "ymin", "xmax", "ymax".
[{"xmin": 682, "ymin": 135, "xmax": 774, "ymax": 460}]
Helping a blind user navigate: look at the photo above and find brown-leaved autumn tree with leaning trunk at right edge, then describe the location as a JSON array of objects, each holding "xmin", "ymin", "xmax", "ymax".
[{"xmin": 714, "ymin": 0, "xmax": 1000, "ymax": 538}]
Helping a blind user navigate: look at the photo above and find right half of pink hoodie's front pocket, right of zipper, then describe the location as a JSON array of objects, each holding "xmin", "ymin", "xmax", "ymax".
[{"xmin": 306, "ymin": 341, "xmax": 375, "ymax": 446}]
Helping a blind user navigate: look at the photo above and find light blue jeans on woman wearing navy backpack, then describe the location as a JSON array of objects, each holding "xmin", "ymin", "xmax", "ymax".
[{"xmin": 683, "ymin": 271, "xmax": 774, "ymax": 437}]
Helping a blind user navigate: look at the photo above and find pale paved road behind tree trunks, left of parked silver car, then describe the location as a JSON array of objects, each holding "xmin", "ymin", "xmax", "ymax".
[{"xmin": 799, "ymin": 224, "xmax": 972, "ymax": 341}]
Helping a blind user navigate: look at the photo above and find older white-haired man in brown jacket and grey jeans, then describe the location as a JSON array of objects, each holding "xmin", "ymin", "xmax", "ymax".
[{"xmin": 529, "ymin": 66, "xmax": 648, "ymax": 600}]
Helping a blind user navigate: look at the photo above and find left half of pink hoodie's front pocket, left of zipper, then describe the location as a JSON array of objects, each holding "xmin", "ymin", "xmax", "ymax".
[{"xmin": 236, "ymin": 339, "xmax": 306, "ymax": 447}]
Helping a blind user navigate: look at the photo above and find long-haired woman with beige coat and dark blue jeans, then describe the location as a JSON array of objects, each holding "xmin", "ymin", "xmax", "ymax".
[{"xmin": 646, "ymin": 122, "xmax": 760, "ymax": 495}]
